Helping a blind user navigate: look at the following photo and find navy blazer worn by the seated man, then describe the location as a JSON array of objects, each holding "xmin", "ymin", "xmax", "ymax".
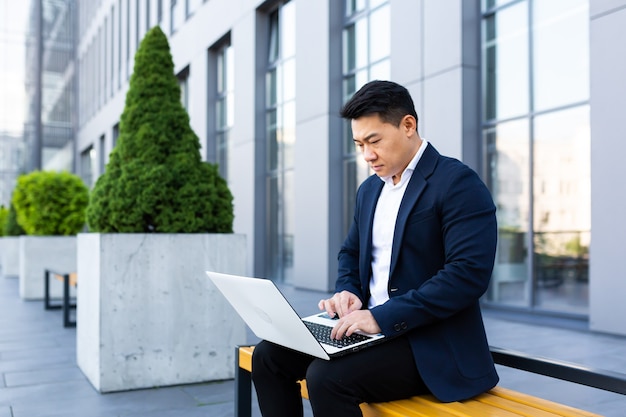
[{"xmin": 336, "ymin": 143, "xmax": 498, "ymax": 402}]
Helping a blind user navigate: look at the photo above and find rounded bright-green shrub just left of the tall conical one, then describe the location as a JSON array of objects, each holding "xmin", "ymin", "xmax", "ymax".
[{"xmin": 12, "ymin": 171, "xmax": 89, "ymax": 236}]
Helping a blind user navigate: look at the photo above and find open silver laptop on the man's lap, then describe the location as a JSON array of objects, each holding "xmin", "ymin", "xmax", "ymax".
[{"xmin": 206, "ymin": 271, "xmax": 385, "ymax": 360}]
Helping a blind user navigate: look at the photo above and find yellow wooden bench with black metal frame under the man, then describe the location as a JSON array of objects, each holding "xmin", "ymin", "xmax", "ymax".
[{"xmin": 235, "ymin": 346, "xmax": 626, "ymax": 417}]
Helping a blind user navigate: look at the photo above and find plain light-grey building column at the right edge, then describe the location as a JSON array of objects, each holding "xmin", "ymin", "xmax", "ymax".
[{"xmin": 589, "ymin": 0, "xmax": 626, "ymax": 335}]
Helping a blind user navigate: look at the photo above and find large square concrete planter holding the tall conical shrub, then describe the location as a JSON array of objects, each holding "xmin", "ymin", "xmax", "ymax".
[{"xmin": 76, "ymin": 233, "xmax": 246, "ymax": 392}]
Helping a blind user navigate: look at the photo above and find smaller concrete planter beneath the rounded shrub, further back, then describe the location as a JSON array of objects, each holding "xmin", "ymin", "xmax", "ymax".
[{"xmin": 19, "ymin": 236, "xmax": 76, "ymax": 300}]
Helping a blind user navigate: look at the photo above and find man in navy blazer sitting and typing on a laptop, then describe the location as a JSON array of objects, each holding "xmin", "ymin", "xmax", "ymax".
[{"xmin": 252, "ymin": 81, "xmax": 498, "ymax": 417}]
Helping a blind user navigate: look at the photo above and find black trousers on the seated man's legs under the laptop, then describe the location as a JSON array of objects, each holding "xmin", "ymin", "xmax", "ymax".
[{"xmin": 252, "ymin": 337, "xmax": 429, "ymax": 417}]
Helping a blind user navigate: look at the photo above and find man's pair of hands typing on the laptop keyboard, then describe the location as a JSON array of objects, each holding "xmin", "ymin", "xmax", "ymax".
[{"xmin": 318, "ymin": 291, "xmax": 380, "ymax": 339}]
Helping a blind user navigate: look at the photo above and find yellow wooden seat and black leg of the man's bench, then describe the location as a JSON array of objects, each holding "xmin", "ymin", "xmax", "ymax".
[{"xmin": 235, "ymin": 346, "xmax": 599, "ymax": 417}]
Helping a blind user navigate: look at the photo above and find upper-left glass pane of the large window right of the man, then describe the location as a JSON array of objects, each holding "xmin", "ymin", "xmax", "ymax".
[{"xmin": 483, "ymin": 1, "xmax": 529, "ymax": 120}]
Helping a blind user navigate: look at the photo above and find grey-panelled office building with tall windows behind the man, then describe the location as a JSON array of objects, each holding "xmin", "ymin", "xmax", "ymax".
[{"xmin": 12, "ymin": 0, "xmax": 626, "ymax": 334}]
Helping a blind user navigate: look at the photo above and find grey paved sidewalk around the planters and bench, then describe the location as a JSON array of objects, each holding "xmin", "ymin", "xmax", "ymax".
[{"xmin": 0, "ymin": 277, "xmax": 626, "ymax": 417}]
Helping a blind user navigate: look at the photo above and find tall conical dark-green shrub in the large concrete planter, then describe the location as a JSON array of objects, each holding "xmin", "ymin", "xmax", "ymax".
[{"xmin": 87, "ymin": 26, "xmax": 233, "ymax": 233}]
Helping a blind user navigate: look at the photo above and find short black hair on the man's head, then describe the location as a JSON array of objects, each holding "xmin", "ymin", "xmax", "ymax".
[{"xmin": 341, "ymin": 80, "xmax": 418, "ymax": 126}]
